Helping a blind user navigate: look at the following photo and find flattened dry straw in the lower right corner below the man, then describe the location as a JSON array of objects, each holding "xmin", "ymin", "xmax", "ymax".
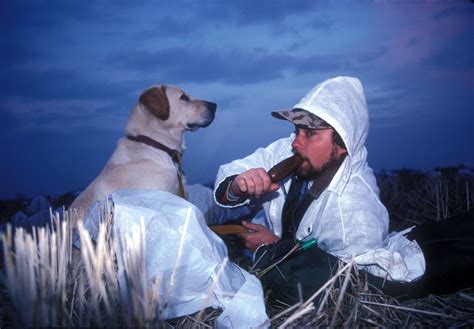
[{"xmin": 270, "ymin": 262, "xmax": 474, "ymax": 328}]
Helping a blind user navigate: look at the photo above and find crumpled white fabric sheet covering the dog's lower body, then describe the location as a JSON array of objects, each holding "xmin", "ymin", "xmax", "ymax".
[{"xmin": 79, "ymin": 190, "xmax": 268, "ymax": 328}]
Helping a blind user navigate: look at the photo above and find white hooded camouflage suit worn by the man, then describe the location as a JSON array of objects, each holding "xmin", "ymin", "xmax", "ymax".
[{"xmin": 215, "ymin": 77, "xmax": 425, "ymax": 282}]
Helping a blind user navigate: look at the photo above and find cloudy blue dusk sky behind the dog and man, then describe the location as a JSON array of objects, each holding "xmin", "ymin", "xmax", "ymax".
[{"xmin": 0, "ymin": 0, "xmax": 474, "ymax": 199}]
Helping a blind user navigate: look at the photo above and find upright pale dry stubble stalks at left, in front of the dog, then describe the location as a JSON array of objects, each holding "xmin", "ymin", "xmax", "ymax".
[{"xmin": 0, "ymin": 206, "xmax": 198, "ymax": 327}]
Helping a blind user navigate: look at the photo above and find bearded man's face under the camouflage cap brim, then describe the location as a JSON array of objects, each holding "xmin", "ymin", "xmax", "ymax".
[{"xmin": 291, "ymin": 127, "xmax": 347, "ymax": 179}]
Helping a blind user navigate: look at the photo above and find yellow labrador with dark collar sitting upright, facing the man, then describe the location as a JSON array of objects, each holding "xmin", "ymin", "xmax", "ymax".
[{"xmin": 70, "ymin": 85, "xmax": 217, "ymax": 211}]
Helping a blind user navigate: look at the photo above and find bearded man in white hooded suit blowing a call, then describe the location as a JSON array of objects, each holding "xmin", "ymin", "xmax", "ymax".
[{"xmin": 215, "ymin": 77, "xmax": 425, "ymax": 300}]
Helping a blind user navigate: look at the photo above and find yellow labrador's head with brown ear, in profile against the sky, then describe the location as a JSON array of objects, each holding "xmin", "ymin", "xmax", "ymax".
[{"xmin": 140, "ymin": 85, "xmax": 217, "ymax": 131}]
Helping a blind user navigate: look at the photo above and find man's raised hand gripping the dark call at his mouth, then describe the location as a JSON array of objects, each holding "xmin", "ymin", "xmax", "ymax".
[{"xmin": 230, "ymin": 168, "xmax": 280, "ymax": 198}]
